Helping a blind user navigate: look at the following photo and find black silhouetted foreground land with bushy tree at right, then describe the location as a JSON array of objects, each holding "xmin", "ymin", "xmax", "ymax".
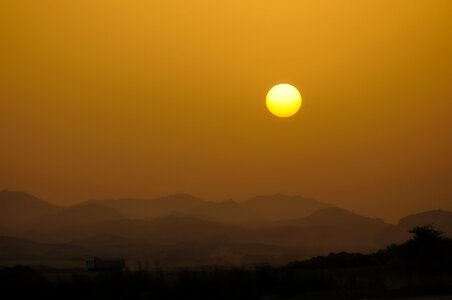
[{"xmin": 0, "ymin": 226, "xmax": 452, "ymax": 300}]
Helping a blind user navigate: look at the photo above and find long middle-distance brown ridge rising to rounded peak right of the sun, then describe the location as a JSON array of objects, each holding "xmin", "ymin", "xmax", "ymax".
[{"xmin": 51, "ymin": 208, "xmax": 396, "ymax": 256}]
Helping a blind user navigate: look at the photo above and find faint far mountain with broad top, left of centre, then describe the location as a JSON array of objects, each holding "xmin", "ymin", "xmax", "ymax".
[{"xmin": 86, "ymin": 194, "xmax": 204, "ymax": 219}]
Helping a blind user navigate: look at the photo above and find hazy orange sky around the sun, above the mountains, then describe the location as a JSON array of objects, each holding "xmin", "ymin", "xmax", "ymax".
[{"xmin": 0, "ymin": 0, "xmax": 452, "ymax": 220}]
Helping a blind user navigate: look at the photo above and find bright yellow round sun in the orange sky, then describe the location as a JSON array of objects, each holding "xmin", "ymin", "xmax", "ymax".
[{"xmin": 267, "ymin": 83, "xmax": 301, "ymax": 118}]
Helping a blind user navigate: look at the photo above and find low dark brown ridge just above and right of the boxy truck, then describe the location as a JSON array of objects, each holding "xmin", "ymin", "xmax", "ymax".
[{"xmin": 70, "ymin": 235, "xmax": 302, "ymax": 268}]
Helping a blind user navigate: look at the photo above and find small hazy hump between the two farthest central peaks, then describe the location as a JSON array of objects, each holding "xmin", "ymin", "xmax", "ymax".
[{"xmin": 188, "ymin": 200, "xmax": 266, "ymax": 225}]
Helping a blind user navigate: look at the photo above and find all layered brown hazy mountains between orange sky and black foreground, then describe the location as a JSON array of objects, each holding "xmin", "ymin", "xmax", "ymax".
[{"xmin": 0, "ymin": 191, "xmax": 452, "ymax": 268}]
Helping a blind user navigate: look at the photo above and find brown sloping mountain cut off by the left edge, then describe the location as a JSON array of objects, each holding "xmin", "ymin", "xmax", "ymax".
[{"xmin": 0, "ymin": 190, "xmax": 60, "ymax": 229}]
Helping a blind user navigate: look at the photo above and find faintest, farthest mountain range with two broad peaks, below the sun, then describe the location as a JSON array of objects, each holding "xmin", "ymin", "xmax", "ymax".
[{"xmin": 87, "ymin": 194, "xmax": 330, "ymax": 225}]
